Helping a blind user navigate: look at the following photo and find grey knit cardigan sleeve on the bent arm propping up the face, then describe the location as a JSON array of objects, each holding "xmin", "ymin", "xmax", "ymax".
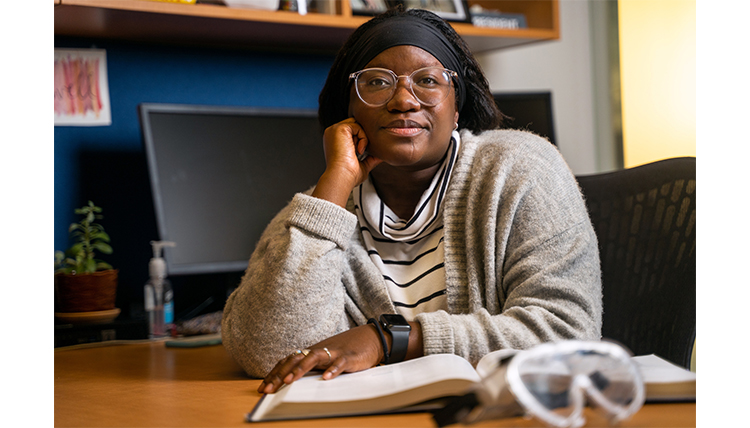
[{"xmin": 221, "ymin": 193, "xmax": 357, "ymax": 377}]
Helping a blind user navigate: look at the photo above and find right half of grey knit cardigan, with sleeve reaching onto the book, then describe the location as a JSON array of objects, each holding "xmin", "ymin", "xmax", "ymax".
[{"xmin": 417, "ymin": 131, "xmax": 602, "ymax": 364}]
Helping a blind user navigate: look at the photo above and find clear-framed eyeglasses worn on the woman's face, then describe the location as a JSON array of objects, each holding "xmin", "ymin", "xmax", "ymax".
[{"xmin": 349, "ymin": 67, "xmax": 458, "ymax": 107}]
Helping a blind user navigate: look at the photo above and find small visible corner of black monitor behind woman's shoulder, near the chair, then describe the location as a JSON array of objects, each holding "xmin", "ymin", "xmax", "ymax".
[{"xmin": 493, "ymin": 92, "xmax": 557, "ymax": 145}]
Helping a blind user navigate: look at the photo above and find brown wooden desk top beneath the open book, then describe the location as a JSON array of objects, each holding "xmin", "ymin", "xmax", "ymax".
[{"xmin": 55, "ymin": 342, "xmax": 696, "ymax": 428}]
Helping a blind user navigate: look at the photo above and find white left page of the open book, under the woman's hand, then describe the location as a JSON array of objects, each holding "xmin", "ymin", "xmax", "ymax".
[{"xmin": 284, "ymin": 354, "xmax": 479, "ymax": 403}]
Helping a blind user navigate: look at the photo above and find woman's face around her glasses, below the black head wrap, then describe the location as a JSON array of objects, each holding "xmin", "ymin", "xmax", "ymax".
[{"xmin": 349, "ymin": 46, "xmax": 458, "ymax": 171}]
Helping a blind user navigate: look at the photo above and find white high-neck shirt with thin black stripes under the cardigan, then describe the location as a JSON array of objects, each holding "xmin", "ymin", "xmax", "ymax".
[{"xmin": 353, "ymin": 131, "xmax": 460, "ymax": 321}]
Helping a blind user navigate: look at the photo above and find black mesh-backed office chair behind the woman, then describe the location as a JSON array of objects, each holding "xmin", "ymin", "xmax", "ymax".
[{"xmin": 576, "ymin": 157, "xmax": 696, "ymax": 368}]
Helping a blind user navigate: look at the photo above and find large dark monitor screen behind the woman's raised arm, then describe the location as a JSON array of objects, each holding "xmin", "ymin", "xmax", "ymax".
[{"xmin": 139, "ymin": 104, "xmax": 325, "ymax": 275}]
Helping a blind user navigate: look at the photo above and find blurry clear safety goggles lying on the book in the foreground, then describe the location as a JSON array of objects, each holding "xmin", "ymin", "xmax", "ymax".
[{"xmin": 436, "ymin": 341, "xmax": 645, "ymax": 428}]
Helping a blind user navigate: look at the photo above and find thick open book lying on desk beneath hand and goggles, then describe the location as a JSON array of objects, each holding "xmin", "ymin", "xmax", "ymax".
[{"xmin": 247, "ymin": 350, "xmax": 695, "ymax": 422}]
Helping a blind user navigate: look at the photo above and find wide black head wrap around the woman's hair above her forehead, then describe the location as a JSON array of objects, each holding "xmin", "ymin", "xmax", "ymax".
[{"xmin": 342, "ymin": 15, "xmax": 466, "ymax": 112}]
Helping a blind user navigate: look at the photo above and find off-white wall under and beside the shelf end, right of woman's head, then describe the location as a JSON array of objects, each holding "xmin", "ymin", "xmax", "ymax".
[{"xmin": 477, "ymin": 0, "xmax": 602, "ymax": 174}]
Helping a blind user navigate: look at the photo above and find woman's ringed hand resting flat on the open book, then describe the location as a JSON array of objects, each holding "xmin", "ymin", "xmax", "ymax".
[{"xmin": 258, "ymin": 324, "xmax": 383, "ymax": 394}]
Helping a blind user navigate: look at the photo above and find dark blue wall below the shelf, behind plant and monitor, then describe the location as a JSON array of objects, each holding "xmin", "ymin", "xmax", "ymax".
[{"xmin": 54, "ymin": 37, "xmax": 333, "ymax": 316}]
